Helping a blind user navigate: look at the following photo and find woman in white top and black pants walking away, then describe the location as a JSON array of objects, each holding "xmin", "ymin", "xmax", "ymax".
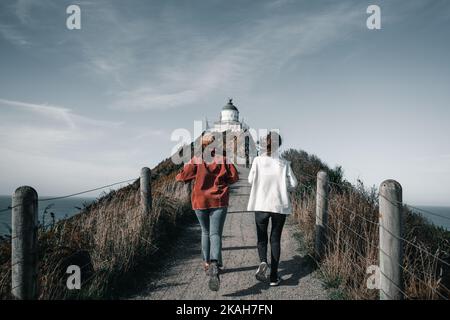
[{"xmin": 247, "ymin": 131, "xmax": 297, "ymax": 286}]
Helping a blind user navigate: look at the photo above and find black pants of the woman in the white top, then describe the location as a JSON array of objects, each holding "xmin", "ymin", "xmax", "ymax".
[{"xmin": 255, "ymin": 211, "xmax": 286, "ymax": 281}]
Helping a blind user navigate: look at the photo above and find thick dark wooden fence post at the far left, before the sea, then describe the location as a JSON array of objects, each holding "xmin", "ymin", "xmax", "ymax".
[{"xmin": 11, "ymin": 186, "xmax": 38, "ymax": 300}]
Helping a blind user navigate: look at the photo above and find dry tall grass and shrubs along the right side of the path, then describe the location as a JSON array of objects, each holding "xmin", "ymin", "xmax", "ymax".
[{"xmin": 284, "ymin": 150, "xmax": 450, "ymax": 299}]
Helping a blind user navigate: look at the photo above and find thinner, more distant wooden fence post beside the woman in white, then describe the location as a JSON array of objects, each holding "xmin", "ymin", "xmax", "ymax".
[{"xmin": 314, "ymin": 171, "xmax": 328, "ymax": 260}]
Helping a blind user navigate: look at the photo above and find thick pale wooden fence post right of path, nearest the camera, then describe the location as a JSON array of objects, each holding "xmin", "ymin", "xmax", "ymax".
[{"xmin": 379, "ymin": 180, "xmax": 403, "ymax": 300}]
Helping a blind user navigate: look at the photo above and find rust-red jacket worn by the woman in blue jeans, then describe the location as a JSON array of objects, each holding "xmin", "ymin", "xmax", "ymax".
[{"xmin": 175, "ymin": 156, "xmax": 239, "ymax": 210}]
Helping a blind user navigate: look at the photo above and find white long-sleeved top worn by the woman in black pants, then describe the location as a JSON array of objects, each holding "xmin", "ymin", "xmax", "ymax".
[{"xmin": 247, "ymin": 155, "xmax": 297, "ymax": 214}]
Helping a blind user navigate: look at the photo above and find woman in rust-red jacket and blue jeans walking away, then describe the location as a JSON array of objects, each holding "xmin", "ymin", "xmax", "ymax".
[{"xmin": 176, "ymin": 134, "xmax": 239, "ymax": 291}]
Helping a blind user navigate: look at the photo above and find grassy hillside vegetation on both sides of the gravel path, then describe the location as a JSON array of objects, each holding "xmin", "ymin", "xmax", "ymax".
[{"xmin": 0, "ymin": 149, "xmax": 450, "ymax": 299}]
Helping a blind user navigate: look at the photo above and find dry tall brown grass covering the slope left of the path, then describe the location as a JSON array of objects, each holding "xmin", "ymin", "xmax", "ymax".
[{"xmin": 0, "ymin": 160, "xmax": 190, "ymax": 299}]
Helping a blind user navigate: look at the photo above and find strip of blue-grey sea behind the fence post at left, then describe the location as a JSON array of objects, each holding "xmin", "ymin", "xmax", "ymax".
[{"xmin": 0, "ymin": 196, "xmax": 95, "ymax": 235}]
